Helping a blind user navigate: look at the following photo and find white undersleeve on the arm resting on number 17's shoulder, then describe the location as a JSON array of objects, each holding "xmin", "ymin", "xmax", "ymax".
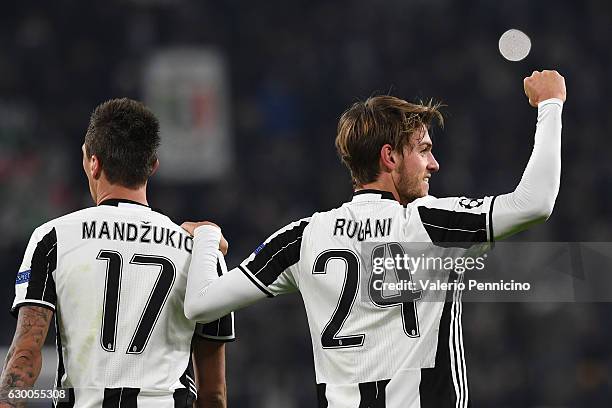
[{"xmin": 184, "ymin": 226, "xmax": 266, "ymax": 323}]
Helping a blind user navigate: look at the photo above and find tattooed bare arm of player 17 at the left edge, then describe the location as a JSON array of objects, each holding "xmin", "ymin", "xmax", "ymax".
[{"xmin": 0, "ymin": 306, "xmax": 53, "ymax": 407}]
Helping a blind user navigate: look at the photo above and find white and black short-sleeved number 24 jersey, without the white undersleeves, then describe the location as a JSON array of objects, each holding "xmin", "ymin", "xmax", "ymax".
[{"xmin": 237, "ymin": 190, "xmax": 494, "ymax": 408}]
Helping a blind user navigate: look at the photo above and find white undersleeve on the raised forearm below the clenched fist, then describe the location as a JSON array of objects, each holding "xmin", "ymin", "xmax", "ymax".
[{"xmin": 492, "ymin": 99, "xmax": 562, "ymax": 240}]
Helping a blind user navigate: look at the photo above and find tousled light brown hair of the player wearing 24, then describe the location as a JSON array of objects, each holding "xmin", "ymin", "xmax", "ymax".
[{"xmin": 336, "ymin": 95, "xmax": 444, "ymax": 186}]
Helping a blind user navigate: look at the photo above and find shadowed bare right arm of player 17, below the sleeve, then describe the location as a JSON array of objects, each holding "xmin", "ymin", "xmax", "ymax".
[{"xmin": 193, "ymin": 336, "xmax": 227, "ymax": 408}]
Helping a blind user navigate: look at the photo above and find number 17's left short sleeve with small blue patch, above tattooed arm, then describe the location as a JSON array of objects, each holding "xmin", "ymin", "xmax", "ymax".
[{"xmin": 11, "ymin": 228, "xmax": 57, "ymax": 316}]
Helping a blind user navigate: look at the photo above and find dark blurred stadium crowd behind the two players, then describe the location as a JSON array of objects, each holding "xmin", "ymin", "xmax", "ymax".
[{"xmin": 0, "ymin": 0, "xmax": 612, "ymax": 408}]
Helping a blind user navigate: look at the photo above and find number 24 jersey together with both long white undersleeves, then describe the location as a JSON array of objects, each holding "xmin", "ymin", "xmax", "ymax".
[{"xmin": 185, "ymin": 99, "xmax": 562, "ymax": 408}]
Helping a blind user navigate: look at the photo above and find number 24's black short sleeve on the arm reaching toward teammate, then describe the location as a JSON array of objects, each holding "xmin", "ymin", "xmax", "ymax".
[{"xmin": 239, "ymin": 218, "xmax": 310, "ymax": 297}]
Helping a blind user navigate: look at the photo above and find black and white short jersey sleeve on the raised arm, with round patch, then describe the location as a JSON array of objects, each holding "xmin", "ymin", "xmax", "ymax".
[{"xmin": 416, "ymin": 196, "xmax": 495, "ymax": 244}]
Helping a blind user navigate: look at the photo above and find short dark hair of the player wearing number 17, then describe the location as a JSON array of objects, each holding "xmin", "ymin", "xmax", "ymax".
[{"xmin": 85, "ymin": 98, "xmax": 160, "ymax": 188}]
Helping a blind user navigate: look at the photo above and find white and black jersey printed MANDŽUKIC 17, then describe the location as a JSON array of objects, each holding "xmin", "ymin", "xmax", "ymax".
[{"xmin": 12, "ymin": 200, "xmax": 234, "ymax": 408}]
